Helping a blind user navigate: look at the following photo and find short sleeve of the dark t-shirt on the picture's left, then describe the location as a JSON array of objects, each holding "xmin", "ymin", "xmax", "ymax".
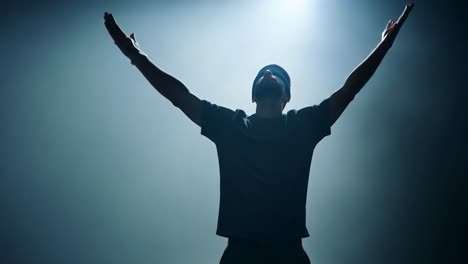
[{"xmin": 200, "ymin": 100, "xmax": 235, "ymax": 143}]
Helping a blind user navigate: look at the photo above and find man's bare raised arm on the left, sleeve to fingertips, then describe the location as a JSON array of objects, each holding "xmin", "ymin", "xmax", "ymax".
[{"xmin": 104, "ymin": 12, "xmax": 201, "ymax": 126}]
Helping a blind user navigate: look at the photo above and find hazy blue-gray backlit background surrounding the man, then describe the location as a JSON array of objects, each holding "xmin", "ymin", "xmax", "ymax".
[{"xmin": 0, "ymin": 0, "xmax": 467, "ymax": 264}]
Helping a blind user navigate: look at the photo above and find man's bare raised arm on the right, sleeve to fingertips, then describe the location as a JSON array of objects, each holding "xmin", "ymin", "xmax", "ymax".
[{"xmin": 329, "ymin": 4, "xmax": 414, "ymax": 126}]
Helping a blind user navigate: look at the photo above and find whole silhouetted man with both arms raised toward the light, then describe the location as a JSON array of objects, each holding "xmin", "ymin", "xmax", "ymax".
[{"xmin": 104, "ymin": 4, "xmax": 413, "ymax": 264}]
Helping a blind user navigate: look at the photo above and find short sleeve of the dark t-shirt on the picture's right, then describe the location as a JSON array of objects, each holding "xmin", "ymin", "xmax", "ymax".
[{"xmin": 296, "ymin": 98, "xmax": 331, "ymax": 142}]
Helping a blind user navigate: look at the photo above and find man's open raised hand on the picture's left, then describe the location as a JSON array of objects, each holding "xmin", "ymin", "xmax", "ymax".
[{"xmin": 104, "ymin": 12, "xmax": 144, "ymax": 61}]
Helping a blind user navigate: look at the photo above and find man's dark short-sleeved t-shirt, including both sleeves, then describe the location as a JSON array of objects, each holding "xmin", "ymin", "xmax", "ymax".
[{"xmin": 201, "ymin": 99, "xmax": 331, "ymax": 240}]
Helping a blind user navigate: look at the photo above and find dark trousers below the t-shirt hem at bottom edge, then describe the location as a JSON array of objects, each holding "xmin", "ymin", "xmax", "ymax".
[{"xmin": 219, "ymin": 238, "xmax": 310, "ymax": 264}]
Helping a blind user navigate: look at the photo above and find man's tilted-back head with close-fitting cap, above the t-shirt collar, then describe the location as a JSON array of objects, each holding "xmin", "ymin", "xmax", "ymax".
[{"xmin": 252, "ymin": 64, "xmax": 291, "ymax": 109}]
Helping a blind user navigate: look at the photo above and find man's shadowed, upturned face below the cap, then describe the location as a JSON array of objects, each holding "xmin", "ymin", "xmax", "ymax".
[{"xmin": 254, "ymin": 70, "xmax": 289, "ymax": 109}]
